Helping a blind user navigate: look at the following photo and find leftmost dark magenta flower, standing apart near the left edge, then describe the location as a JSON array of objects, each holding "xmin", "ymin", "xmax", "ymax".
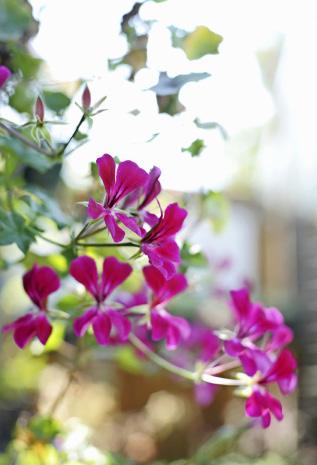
[{"xmin": 2, "ymin": 264, "xmax": 60, "ymax": 349}]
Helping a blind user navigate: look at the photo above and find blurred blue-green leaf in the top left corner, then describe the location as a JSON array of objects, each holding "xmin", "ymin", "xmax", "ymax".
[{"xmin": 0, "ymin": 0, "xmax": 36, "ymax": 42}]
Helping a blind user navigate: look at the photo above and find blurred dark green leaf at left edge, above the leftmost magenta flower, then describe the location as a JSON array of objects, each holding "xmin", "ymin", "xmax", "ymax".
[{"xmin": 0, "ymin": 207, "xmax": 35, "ymax": 253}]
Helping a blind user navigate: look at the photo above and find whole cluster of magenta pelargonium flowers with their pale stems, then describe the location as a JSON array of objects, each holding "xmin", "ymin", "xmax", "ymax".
[{"xmin": 2, "ymin": 154, "xmax": 297, "ymax": 427}]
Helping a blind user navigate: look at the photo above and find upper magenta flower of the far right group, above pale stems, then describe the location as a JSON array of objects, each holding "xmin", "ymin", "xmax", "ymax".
[{"xmin": 224, "ymin": 288, "xmax": 293, "ymax": 376}]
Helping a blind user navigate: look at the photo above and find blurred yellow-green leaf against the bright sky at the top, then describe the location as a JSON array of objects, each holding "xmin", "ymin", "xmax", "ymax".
[{"xmin": 182, "ymin": 26, "xmax": 223, "ymax": 60}]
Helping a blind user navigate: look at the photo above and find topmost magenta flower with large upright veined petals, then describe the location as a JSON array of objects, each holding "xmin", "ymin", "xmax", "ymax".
[{"xmin": 88, "ymin": 154, "xmax": 148, "ymax": 242}]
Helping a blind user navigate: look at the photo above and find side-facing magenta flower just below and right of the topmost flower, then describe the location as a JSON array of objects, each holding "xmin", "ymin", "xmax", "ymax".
[{"xmin": 141, "ymin": 203, "xmax": 187, "ymax": 278}]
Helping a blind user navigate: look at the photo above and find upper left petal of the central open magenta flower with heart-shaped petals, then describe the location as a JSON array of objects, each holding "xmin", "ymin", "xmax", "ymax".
[{"xmin": 69, "ymin": 255, "xmax": 99, "ymax": 299}]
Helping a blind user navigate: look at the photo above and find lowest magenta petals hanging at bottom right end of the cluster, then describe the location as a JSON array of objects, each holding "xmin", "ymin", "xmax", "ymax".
[{"xmin": 245, "ymin": 390, "xmax": 283, "ymax": 428}]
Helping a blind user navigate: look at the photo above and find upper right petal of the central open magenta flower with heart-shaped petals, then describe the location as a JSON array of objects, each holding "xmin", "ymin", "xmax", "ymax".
[{"xmin": 101, "ymin": 257, "xmax": 132, "ymax": 300}]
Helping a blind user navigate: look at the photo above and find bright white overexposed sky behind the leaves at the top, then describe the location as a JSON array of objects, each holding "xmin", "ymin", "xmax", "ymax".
[{"xmin": 27, "ymin": 0, "xmax": 317, "ymax": 212}]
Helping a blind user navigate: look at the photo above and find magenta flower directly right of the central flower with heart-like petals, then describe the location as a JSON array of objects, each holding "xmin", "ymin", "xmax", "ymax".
[{"xmin": 143, "ymin": 266, "xmax": 190, "ymax": 350}]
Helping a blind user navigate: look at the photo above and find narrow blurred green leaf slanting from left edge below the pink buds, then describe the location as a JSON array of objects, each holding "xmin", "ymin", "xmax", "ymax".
[{"xmin": 0, "ymin": 136, "xmax": 55, "ymax": 173}]
